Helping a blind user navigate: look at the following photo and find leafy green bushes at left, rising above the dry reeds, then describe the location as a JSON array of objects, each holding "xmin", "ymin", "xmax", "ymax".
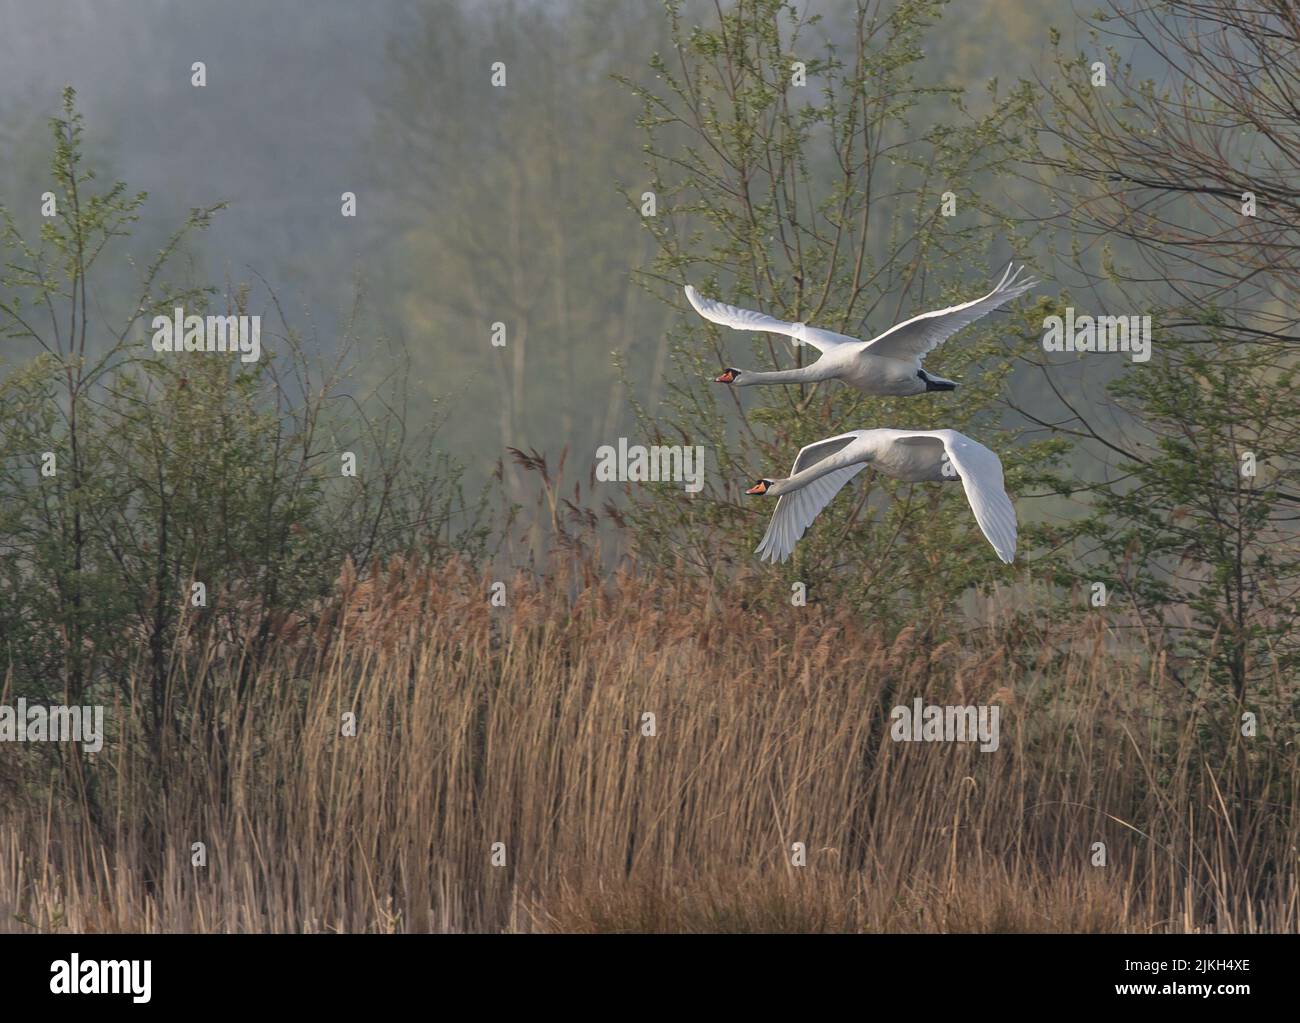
[{"xmin": 0, "ymin": 90, "xmax": 488, "ymax": 741}]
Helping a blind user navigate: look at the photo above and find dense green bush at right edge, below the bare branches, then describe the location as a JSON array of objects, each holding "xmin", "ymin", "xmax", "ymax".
[{"xmin": 1060, "ymin": 337, "xmax": 1300, "ymax": 699}]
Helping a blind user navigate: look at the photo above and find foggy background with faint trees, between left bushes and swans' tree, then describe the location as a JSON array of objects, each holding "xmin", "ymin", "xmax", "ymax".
[{"xmin": 0, "ymin": 0, "xmax": 1086, "ymax": 496}]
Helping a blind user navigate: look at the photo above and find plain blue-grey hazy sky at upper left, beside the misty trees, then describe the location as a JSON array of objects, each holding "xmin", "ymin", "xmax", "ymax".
[{"xmin": 0, "ymin": 0, "xmax": 411, "ymax": 335}]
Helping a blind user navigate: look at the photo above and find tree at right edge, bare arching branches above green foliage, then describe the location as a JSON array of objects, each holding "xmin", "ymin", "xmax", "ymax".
[{"xmin": 1026, "ymin": 0, "xmax": 1300, "ymax": 702}]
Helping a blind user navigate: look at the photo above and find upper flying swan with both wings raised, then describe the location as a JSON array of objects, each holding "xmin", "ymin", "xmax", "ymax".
[{"xmin": 686, "ymin": 264, "xmax": 1039, "ymax": 396}]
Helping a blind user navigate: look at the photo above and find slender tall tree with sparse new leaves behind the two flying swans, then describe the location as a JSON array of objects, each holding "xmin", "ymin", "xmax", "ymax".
[{"xmin": 618, "ymin": 0, "xmax": 1061, "ymax": 619}]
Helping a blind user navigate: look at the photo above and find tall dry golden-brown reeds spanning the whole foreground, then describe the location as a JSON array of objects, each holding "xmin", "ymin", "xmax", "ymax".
[{"xmin": 0, "ymin": 564, "xmax": 1300, "ymax": 932}]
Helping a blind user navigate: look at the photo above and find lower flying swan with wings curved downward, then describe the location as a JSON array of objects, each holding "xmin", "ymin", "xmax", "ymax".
[{"xmin": 745, "ymin": 430, "xmax": 1015, "ymax": 564}]
